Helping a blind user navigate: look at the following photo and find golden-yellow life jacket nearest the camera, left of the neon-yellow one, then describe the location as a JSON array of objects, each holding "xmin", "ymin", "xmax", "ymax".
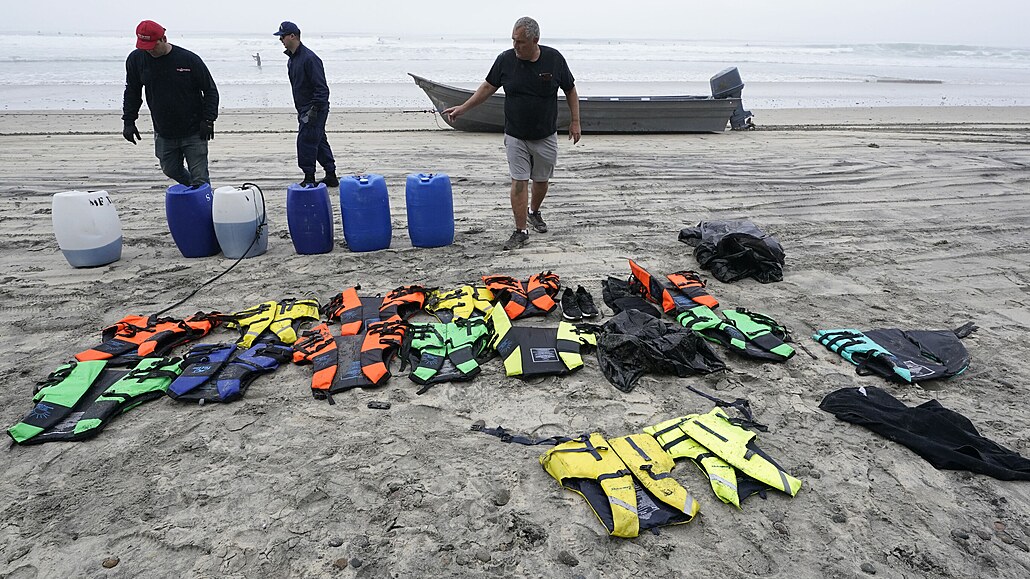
[{"xmin": 539, "ymin": 430, "xmax": 700, "ymax": 537}]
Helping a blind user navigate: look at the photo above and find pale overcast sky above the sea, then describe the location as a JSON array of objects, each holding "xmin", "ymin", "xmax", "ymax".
[{"xmin": 8, "ymin": 0, "xmax": 1030, "ymax": 47}]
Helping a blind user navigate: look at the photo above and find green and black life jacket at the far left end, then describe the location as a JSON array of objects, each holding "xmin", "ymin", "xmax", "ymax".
[{"xmin": 7, "ymin": 357, "xmax": 182, "ymax": 444}]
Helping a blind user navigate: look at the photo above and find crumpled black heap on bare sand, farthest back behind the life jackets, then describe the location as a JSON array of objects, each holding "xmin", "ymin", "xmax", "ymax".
[{"xmin": 680, "ymin": 219, "xmax": 785, "ymax": 283}]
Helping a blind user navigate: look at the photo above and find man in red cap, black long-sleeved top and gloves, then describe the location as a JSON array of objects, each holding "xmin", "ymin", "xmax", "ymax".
[{"xmin": 122, "ymin": 21, "xmax": 218, "ymax": 186}]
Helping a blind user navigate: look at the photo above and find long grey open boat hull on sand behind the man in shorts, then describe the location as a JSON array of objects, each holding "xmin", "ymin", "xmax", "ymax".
[{"xmin": 408, "ymin": 72, "xmax": 750, "ymax": 133}]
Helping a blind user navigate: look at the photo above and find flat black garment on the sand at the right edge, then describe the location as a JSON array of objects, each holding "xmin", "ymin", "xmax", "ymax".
[{"xmin": 819, "ymin": 386, "xmax": 1030, "ymax": 480}]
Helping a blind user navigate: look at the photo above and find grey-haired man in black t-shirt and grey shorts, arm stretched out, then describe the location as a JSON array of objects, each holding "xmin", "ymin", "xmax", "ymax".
[{"xmin": 443, "ymin": 16, "xmax": 582, "ymax": 249}]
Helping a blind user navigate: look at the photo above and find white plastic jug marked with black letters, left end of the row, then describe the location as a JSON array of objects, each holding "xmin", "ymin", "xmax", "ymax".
[{"xmin": 52, "ymin": 191, "xmax": 122, "ymax": 268}]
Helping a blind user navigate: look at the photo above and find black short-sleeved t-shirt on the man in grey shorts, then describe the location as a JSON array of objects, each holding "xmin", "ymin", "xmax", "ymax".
[{"xmin": 486, "ymin": 45, "xmax": 576, "ymax": 140}]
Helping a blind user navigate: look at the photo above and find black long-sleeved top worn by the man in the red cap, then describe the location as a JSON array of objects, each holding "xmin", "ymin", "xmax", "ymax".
[{"xmin": 122, "ymin": 45, "xmax": 218, "ymax": 138}]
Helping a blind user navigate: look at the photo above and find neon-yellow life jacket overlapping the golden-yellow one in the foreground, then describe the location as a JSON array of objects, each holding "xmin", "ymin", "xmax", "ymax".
[{"xmin": 644, "ymin": 408, "xmax": 801, "ymax": 508}]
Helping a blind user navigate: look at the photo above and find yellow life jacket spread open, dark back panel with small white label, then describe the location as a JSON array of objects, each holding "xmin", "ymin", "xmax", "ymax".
[{"xmin": 487, "ymin": 308, "xmax": 597, "ymax": 377}]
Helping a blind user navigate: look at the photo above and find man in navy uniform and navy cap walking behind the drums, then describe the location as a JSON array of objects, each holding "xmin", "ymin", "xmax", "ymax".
[{"xmin": 275, "ymin": 22, "xmax": 340, "ymax": 186}]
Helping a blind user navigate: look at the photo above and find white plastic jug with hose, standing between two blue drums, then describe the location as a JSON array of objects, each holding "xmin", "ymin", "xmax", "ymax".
[{"xmin": 211, "ymin": 183, "xmax": 268, "ymax": 260}]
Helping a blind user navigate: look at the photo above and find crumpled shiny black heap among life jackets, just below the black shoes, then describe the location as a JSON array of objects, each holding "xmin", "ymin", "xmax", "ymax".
[{"xmin": 597, "ymin": 309, "xmax": 726, "ymax": 393}]
